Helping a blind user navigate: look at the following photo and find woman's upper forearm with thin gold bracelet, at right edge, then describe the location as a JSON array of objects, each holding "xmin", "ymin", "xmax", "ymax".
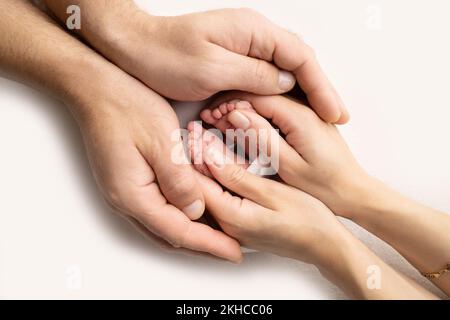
[{"xmin": 354, "ymin": 179, "xmax": 450, "ymax": 294}]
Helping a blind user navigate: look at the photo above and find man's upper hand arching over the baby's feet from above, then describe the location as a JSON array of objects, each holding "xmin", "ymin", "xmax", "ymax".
[{"xmin": 44, "ymin": 0, "xmax": 348, "ymax": 123}]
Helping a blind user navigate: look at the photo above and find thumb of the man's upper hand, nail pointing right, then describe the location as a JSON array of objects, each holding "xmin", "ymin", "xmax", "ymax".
[{"xmin": 221, "ymin": 52, "xmax": 296, "ymax": 95}]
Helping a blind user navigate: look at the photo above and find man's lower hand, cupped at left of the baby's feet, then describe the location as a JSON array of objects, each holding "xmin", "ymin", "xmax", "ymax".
[{"xmin": 72, "ymin": 66, "xmax": 241, "ymax": 262}]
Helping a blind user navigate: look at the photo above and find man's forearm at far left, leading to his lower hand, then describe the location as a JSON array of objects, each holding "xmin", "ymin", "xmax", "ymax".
[{"xmin": 0, "ymin": 0, "xmax": 75, "ymax": 99}]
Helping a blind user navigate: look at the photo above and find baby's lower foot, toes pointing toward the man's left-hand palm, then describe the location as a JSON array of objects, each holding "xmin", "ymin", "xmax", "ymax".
[{"xmin": 188, "ymin": 121, "xmax": 249, "ymax": 178}]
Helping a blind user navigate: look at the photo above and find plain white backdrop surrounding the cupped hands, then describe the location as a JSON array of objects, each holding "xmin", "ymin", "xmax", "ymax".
[{"xmin": 0, "ymin": 0, "xmax": 450, "ymax": 299}]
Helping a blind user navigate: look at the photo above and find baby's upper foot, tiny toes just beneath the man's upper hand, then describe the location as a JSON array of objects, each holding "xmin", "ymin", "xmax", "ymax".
[{"xmin": 200, "ymin": 100, "xmax": 256, "ymax": 133}]
